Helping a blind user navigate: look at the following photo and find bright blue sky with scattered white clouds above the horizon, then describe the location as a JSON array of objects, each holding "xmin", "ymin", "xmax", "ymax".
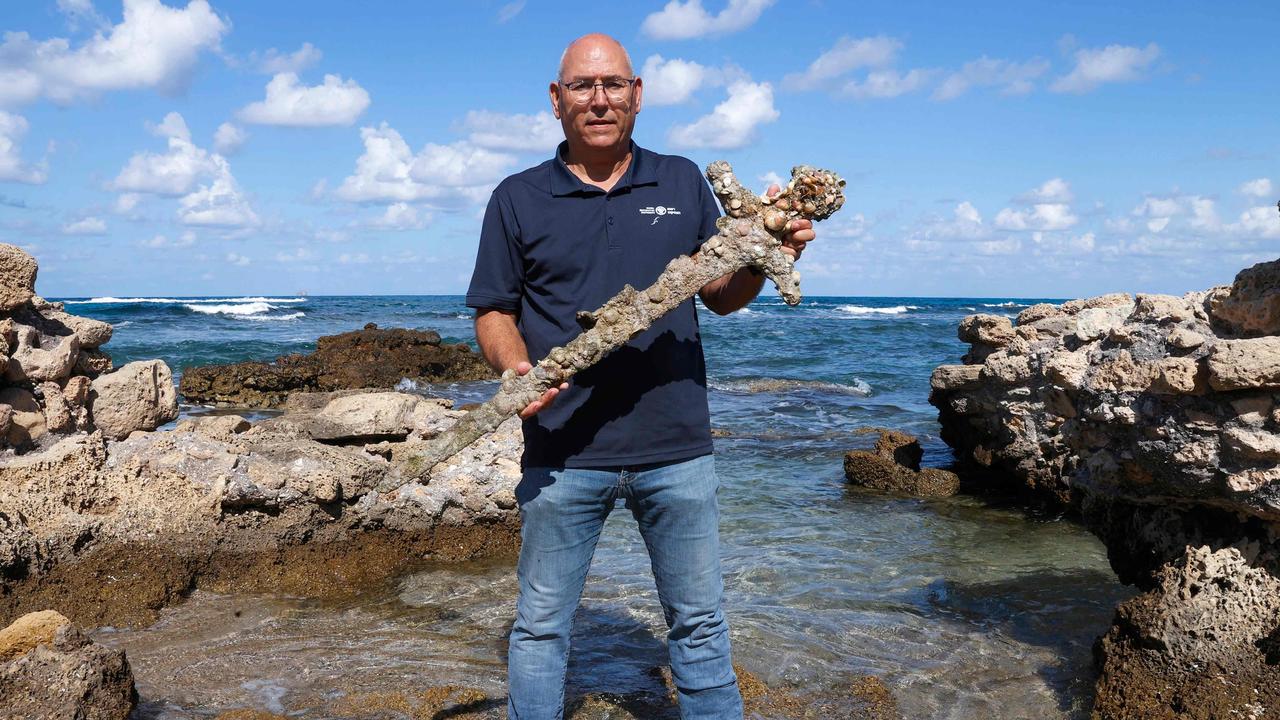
[{"xmin": 0, "ymin": 0, "xmax": 1280, "ymax": 297}]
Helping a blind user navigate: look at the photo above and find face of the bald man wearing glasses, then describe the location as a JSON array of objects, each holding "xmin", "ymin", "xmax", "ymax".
[{"xmin": 550, "ymin": 41, "xmax": 643, "ymax": 151}]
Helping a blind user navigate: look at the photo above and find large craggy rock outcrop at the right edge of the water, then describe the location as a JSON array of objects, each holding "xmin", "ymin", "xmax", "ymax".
[{"xmin": 929, "ymin": 256, "xmax": 1280, "ymax": 719}]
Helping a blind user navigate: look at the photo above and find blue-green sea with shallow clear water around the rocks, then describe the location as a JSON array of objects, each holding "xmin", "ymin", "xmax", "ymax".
[{"xmin": 60, "ymin": 296, "xmax": 1134, "ymax": 720}]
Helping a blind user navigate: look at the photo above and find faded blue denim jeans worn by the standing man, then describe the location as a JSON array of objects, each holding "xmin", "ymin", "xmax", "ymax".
[{"xmin": 507, "ymin": 455, "xmax": 742, "ymax": 720}]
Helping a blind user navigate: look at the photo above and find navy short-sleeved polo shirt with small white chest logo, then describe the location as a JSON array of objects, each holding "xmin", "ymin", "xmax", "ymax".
[{"xmin": 467, "ymin": 142, "xmax": 719, "ymax": 468}]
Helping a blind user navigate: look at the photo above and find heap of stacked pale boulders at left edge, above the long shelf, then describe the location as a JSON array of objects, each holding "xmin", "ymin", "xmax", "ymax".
[{"xmin": 0, "ymin": 243, "xmax": 178, "ymax": 452}]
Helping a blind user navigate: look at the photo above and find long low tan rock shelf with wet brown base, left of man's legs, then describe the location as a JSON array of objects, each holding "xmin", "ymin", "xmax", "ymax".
[{"xmin": 0, "ymin": 391, "xmax": 522, "ymax": 624}]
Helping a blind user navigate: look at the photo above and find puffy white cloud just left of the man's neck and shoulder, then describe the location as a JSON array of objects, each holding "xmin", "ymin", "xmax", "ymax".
[{"xmin": 334, "ymin": 123, "xmax": 516, "ymax": 208}]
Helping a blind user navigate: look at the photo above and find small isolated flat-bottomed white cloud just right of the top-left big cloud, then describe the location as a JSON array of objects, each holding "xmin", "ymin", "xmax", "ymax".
[{"xmin": 236, "ymin": 73, "xmax": 369, "ymax": 127}]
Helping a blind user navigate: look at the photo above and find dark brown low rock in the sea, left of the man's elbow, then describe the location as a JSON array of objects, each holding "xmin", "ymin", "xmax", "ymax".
[{"xmin": 179, "ymin": 323, "xmax": 497, "ymax": 407}]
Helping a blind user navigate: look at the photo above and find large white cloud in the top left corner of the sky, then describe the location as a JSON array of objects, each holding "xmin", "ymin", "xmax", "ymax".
[{"xmin": 0, "ymin": 0, "xmax": 229, "ymax": 105}]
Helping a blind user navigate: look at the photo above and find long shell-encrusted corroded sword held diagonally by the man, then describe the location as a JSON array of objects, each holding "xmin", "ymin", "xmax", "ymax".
[{"xmin": 378, "ymin": 160, "xmax": 845, "ymax": 492}]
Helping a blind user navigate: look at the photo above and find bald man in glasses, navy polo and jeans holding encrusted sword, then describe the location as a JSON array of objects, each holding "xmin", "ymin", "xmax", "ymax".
[{"xmin": 467, "ymin": 35, "xmax": 814, "ymax": 720}]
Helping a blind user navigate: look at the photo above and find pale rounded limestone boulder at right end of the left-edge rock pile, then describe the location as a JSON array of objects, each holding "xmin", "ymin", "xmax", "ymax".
[{"xmin": 90, "ymin": 360, "xmax": 178, "ymax": 439}]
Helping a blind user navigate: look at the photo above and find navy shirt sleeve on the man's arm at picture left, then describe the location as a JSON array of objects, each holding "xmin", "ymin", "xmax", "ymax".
[{"xmin": 467, "ymin": 191, "xmax": 525, "ymax": 310}]
